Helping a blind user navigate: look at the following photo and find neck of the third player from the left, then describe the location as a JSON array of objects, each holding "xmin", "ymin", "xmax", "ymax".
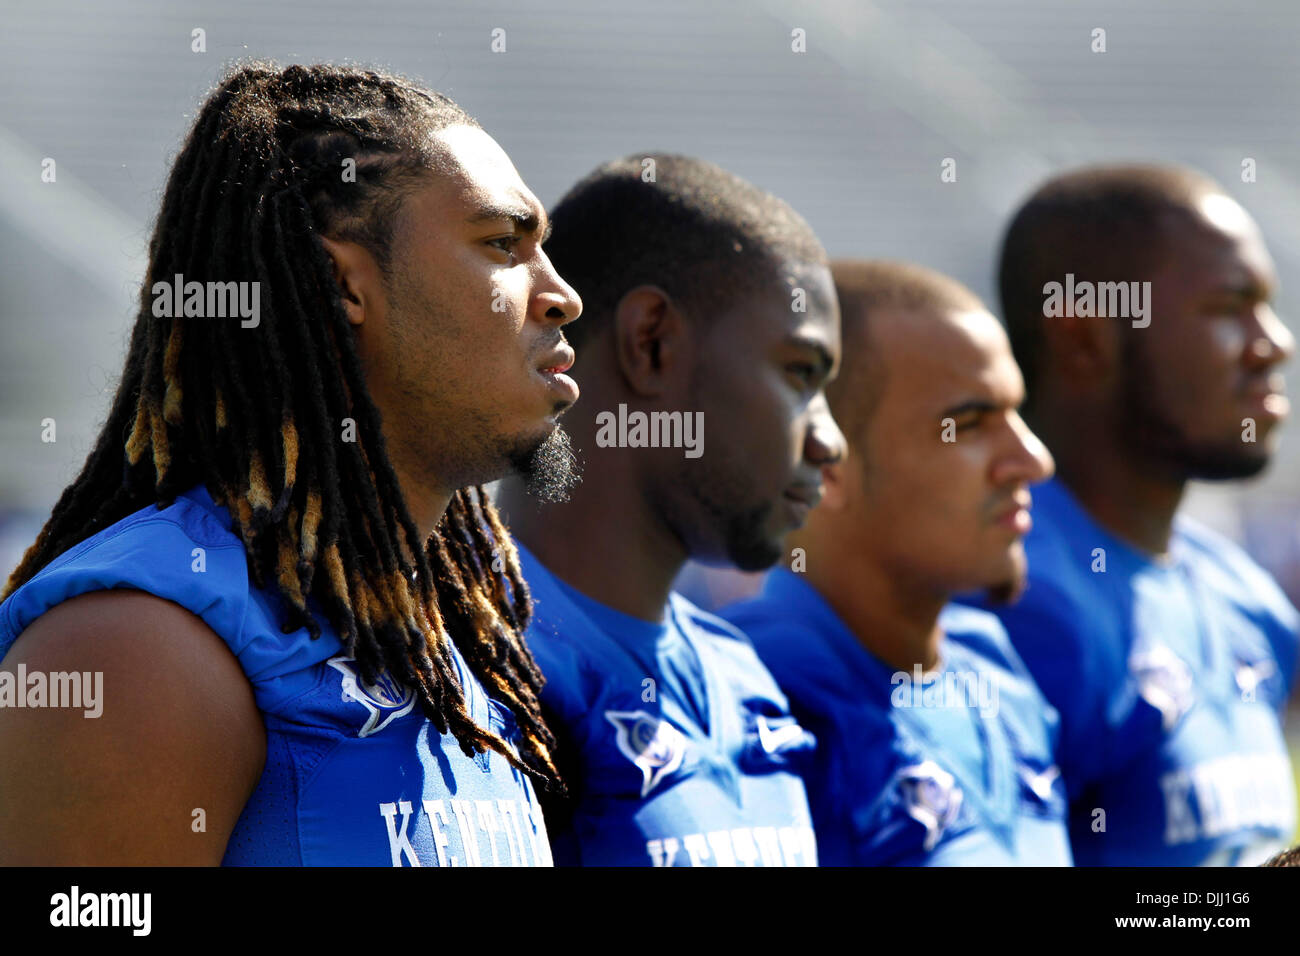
[{"xmin": 806, "ymin": 540, "xmax": 948, "ymax": 672}]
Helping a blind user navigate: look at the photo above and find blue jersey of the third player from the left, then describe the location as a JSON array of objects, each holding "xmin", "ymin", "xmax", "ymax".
[{"xmin": 723, "ymin": 568, "xmax": 1070, "ymax": 866}]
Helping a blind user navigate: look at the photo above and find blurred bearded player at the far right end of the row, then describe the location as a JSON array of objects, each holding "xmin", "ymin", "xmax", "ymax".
[{"xmin": 967, "ymin": 166, "xmax": 1297, "ymax": 866}]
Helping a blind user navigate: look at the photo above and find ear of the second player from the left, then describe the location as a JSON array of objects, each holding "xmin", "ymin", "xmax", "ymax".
[{"xmin": 614, "ymin": 285, "xmax": 690, "ymax": 398}]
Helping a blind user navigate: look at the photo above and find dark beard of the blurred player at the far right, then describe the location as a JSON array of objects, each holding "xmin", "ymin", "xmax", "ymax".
[{"xmin": 1121, "ymin": 336, "xmax": 1269, "ymax": 481}]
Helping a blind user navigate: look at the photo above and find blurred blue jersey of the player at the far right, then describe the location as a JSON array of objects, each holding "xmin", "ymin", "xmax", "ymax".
[{"xmin": 961, "ymin": 480, "xmax": 1297, "ymax": 866}]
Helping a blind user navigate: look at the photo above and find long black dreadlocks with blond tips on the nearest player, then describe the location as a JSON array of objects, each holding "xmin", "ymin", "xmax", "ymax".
[{"xmin": 5, "ymin": 61, "xmax": 558, "ymax": 784}]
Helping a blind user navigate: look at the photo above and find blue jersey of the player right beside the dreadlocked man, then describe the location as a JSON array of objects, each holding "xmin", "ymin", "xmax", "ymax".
[{"xmin": 519, "ymin": 546, "xmax": 816, "ymax": 866}]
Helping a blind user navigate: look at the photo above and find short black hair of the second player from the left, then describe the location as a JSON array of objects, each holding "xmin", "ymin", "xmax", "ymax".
[{"xmin": 546, "ymin": 152, "xmax": 827, "ymax": 349}]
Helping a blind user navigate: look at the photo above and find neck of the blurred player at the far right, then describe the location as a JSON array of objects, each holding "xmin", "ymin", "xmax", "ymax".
[{"xmin": 1034, "ymin": 408, "xmax": 1187, "ymax": 557}]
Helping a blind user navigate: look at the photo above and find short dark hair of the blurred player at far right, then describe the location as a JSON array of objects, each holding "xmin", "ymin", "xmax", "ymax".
[{"xmin": 997, "ymin": 164, "xmax": 1226, "ymax": 406}]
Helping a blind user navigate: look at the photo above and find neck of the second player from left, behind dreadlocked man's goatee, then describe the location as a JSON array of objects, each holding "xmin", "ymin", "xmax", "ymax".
[{"xmin": 497, "ymin": 434, "xmax": 688, "ymax": 622}]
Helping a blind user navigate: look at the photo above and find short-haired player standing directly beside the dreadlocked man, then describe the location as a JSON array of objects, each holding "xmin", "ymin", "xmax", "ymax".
[{"xmin": 502, "ymin": 155, "xmax": 844, "ymax": 866}]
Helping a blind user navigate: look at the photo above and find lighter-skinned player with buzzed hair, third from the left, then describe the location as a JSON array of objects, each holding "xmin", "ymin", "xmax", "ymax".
[{"xmin": 723, "ymin": 261, "xmax": 1070, "ymax": 866}]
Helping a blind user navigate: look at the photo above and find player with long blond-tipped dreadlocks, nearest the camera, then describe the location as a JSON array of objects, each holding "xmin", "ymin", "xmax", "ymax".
[{"xmin": 0, "ymin": 64, "xmax": 581, "ymax": 866}]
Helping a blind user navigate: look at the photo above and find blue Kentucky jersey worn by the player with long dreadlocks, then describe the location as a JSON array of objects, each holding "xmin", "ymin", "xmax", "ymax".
[{"xmin": 0, "ymin": 485, "xmax": 551, "ymax": 866}]
